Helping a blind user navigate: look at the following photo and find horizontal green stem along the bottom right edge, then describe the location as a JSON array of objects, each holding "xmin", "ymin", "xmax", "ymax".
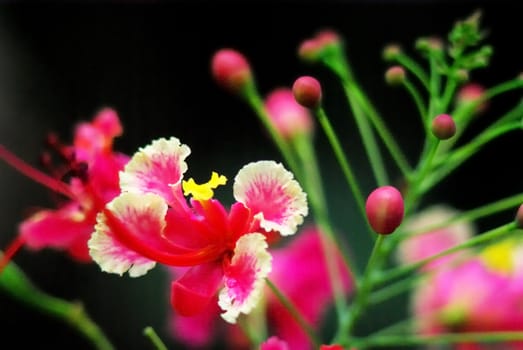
[{"xmin": 362, "ymin": 332, "xmax": 523, "ymax": 348}]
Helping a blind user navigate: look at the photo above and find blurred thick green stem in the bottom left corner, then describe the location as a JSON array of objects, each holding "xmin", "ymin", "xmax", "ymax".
[{"xmin": 0, "ymin": 262, "xmax": 114, "ymax": 350}]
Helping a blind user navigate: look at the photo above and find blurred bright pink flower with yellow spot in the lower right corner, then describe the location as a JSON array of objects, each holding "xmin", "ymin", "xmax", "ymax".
[{"xmin": 412, "ymin": 253, "xmax": 523, "ymax": 349}]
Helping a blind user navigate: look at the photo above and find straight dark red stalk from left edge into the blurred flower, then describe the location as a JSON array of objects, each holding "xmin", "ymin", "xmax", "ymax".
[{"xmin": 0, "ymin": 145, "xmax": 75, "ymax": 199}]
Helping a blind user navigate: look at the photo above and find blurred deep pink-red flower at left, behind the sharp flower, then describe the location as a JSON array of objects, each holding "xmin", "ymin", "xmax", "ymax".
[{"xmin": 0, "ymin": 108, "xmax": 129, "ymax": 262}]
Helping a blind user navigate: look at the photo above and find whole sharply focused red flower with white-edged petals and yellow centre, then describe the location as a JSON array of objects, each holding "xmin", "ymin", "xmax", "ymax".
[{"xmin": 89, "ymin": 137, "xmax": 308, "ymax": 323}]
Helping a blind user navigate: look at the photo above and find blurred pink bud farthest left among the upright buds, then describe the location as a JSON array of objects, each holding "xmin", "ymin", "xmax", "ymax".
[{"xmin": 211, "ymin": 49, "xmax": 252, "ymax": 93}]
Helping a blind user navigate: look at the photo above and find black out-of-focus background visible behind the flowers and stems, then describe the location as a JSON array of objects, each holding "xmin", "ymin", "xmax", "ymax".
[{"xmin": 0, "ymin": 1, "xmax": 523, "ymax": 349}]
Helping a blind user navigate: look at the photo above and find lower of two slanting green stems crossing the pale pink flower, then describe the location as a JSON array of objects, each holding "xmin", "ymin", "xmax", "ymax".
[{"xmin": 376, "ymin": 222, "xmax": 518, "ymax": 284}]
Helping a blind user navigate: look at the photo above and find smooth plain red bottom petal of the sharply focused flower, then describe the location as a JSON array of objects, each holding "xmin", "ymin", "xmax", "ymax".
[{"xmin": 171, "ymin": 261, "xmax": 223, "ymax": 316}]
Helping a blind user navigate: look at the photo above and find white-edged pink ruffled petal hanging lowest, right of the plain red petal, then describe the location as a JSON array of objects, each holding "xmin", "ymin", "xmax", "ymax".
[{"xmin": 218, "ymin": 233, "xmax": 272, "ymax": 323}]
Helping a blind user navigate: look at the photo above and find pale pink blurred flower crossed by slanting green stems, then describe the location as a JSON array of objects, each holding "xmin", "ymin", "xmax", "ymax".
[{"xmin": 396, "ymin": 205, "xmax": 476, "ymax": 271}]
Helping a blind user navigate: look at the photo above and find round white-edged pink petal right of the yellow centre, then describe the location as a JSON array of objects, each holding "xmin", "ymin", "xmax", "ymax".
[{"xmin": 234, "ymin": 161, "xmax": 308, "ymax": 236}]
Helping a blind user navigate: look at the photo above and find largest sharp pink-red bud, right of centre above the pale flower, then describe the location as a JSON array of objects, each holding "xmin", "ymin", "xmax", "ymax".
[{"xmin": 365, "ymin": 186, "xmax": 404, "ymax": 235}]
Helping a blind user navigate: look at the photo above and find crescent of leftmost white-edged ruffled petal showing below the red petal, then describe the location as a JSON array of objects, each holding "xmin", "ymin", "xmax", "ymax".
[{"xmin": 88, "ymin": 213, "xmax": 156, "ymax": 277}]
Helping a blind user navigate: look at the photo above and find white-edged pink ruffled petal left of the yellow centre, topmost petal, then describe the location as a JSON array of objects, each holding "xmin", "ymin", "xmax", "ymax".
[{"xmin": 120, "ymin": 137, "xmax": 191, "ymax": 204}]
